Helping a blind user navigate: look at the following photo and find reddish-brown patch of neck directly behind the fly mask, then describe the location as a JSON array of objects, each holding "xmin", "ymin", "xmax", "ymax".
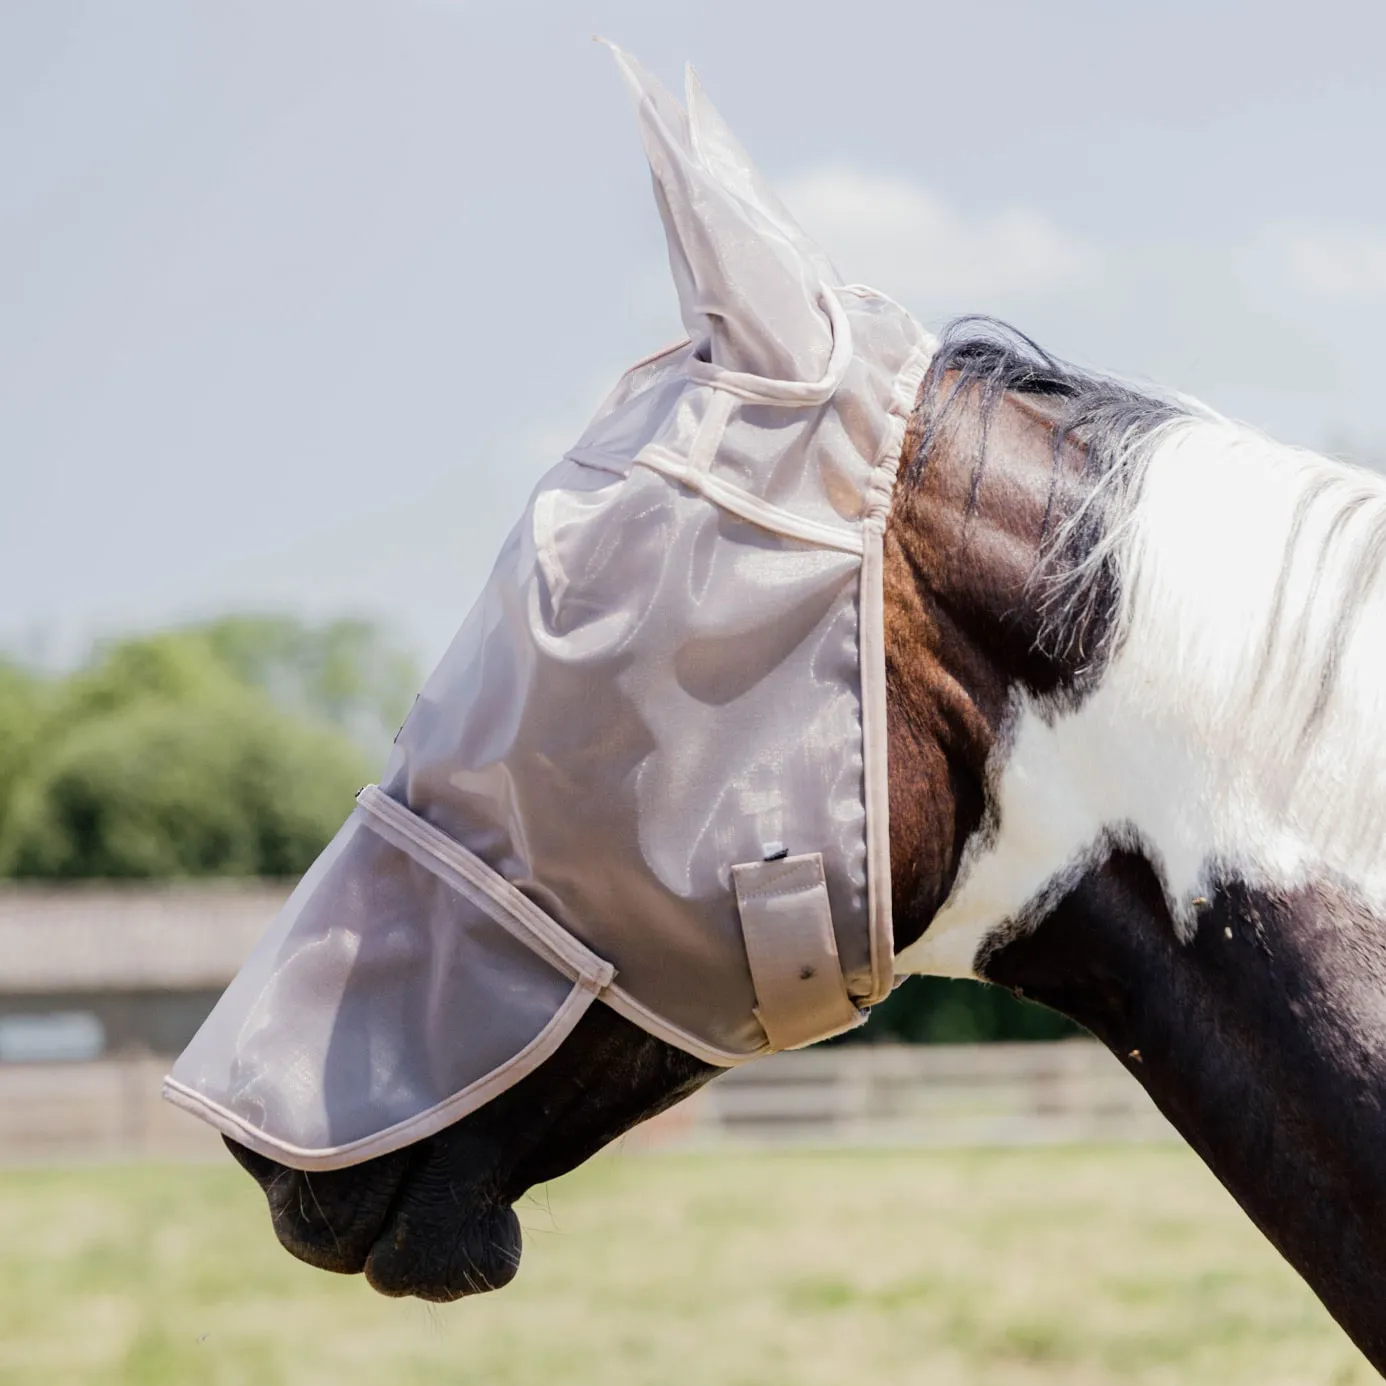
[{"xmin": 884, "ymin": 387, "xmax": 1108, "ymax": 951}]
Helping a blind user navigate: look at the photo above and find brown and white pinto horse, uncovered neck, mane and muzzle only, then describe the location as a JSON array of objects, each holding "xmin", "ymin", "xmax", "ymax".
[{"xmin": 195, "ymin": 48, "xmax": 1386, "ymax": 1372}]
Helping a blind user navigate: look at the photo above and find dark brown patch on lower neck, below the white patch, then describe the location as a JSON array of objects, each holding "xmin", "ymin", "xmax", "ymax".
[{"xmin": 980, "ymin": 850, "xmax": 1386, "ymax": 1371}]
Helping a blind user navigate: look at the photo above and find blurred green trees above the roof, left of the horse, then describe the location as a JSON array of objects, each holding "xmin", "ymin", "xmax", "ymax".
[{"xmin": 0, "ymin": 617, "xmax": 413, "ymax": 879}]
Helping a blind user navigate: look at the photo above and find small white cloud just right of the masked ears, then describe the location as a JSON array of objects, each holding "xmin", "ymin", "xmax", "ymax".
[{"xmin": 783, "ymin": 165, "xmax": 1096, "ymax": 306}]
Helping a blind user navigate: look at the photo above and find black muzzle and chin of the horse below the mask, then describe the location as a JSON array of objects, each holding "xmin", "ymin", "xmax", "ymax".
[{"xmin": 226, "ymin": 1006, "xmax": 717, "ymax": 1303}]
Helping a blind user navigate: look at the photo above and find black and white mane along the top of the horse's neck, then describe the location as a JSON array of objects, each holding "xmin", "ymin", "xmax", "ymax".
[{"xmin": 905, "ymin": 317, "xmax": 1386, "ymax": 809}]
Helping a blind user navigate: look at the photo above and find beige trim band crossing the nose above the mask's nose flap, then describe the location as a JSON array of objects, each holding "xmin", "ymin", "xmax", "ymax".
[{"xmin": 356, "ymin": 784, "xmax": 615, "ymax": 992}]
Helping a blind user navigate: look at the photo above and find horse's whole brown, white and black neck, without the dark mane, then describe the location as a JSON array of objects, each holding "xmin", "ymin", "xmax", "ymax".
[{"xmin": 887, "ymin": 385, "xmax": 1386, "ymax": 1369}]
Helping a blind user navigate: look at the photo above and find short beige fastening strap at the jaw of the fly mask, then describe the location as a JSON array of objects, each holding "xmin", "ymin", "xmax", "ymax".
[{"xmin": 732, "ymin": 852, "xmax": 865, "ymax": 1049}]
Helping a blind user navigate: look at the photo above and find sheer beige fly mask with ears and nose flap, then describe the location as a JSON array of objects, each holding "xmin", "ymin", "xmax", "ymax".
[{"xmin": 165, "ymin": 43, "xmax": 931, "ymax": 1170}]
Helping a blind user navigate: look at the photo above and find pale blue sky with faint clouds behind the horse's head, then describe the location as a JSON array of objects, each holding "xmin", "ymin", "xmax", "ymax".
[{"xmin": 0, "ymin": 0, "xmax": 1386, "ymax": 664}]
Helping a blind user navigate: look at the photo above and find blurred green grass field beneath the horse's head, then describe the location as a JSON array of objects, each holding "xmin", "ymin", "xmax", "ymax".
[{"xmin": 0, "ymin": 1148, "xmax": 1376, "ymax": 1386}]
